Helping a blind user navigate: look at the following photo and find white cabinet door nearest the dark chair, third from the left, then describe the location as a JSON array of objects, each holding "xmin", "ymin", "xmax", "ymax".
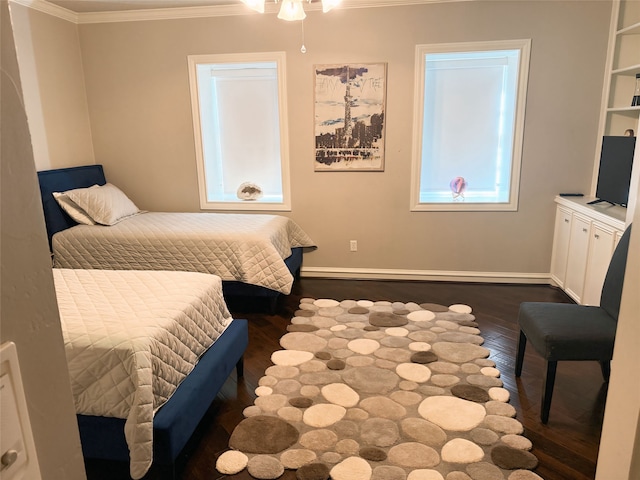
[{"xmin": 582, "ymin": 223, "xmax": 615, "ymax": 305}]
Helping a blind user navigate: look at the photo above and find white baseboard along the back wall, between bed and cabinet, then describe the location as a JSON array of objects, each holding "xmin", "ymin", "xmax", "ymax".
[{"xmin": 300, "ymin": 266, "xmax": 552, "ymax": 284}]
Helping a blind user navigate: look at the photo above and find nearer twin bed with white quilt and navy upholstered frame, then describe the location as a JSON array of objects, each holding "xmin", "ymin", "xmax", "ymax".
[{"xmin": 53, "ymin": 269, "xmax": 248, "ymax": 479}]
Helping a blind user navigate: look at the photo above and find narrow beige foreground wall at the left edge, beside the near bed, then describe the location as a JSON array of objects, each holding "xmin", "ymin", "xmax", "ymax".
[{"xmin": 0, "ymin": 0, "xmax": 86, "ymax": 480}]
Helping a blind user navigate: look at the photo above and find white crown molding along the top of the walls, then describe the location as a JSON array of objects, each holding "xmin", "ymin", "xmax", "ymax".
[{"xmin": 9, "ymin": 0, "xmax": 460, "ymax": 24}]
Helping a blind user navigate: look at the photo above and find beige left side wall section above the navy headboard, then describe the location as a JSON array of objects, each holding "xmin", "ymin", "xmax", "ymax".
[{"xmin": 12, "ymin": 4, "xmax": 94, "ymax": 170}]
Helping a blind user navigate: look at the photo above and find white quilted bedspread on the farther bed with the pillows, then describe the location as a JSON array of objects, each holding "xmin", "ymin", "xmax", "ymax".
[{"xmin": 53, "ymin": 212, "xmax": 315, "ymax": 294}]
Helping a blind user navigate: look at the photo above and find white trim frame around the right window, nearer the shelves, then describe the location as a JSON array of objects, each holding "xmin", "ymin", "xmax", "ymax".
[{"xmin": 410, "ymin": 39, "xmax": 531, "ymax": 212}]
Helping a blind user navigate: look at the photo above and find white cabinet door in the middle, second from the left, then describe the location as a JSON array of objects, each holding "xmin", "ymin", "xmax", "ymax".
[{"xmin": 564, "ymin": 214, "xmax": 591, "ymax": 303}]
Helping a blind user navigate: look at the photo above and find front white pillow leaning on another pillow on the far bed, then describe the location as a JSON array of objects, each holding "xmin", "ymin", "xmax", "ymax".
[{"xmin": 64, "ymin": 183, "xmax": 140, "ymax": 225}]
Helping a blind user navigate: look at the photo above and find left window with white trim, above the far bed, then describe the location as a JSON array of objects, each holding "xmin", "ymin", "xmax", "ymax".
[{"xmin": 188, "ymin": 52, "xmax": 291, "ymax": 210}]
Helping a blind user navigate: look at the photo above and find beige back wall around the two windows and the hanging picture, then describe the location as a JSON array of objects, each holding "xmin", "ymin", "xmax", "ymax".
[{"xmin": 72, "ymin": 1, "xmax": 611, "ymax": 281}]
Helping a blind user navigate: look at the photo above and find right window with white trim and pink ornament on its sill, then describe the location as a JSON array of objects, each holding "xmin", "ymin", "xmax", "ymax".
[{"xmin": 411, "ymin": 40, "xmax": 530, "ymax": 211}]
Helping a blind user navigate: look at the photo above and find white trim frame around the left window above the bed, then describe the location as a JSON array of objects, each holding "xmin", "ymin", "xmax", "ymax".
[{"xmin": 187, "ymin": 52, "xmax": 291, "ymax": 211}]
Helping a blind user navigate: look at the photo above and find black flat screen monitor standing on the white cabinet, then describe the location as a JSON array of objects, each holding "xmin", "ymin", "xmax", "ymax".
[{"xmin": 589, "ymin": 137, "xmax": 636, "ymax": 207}]
